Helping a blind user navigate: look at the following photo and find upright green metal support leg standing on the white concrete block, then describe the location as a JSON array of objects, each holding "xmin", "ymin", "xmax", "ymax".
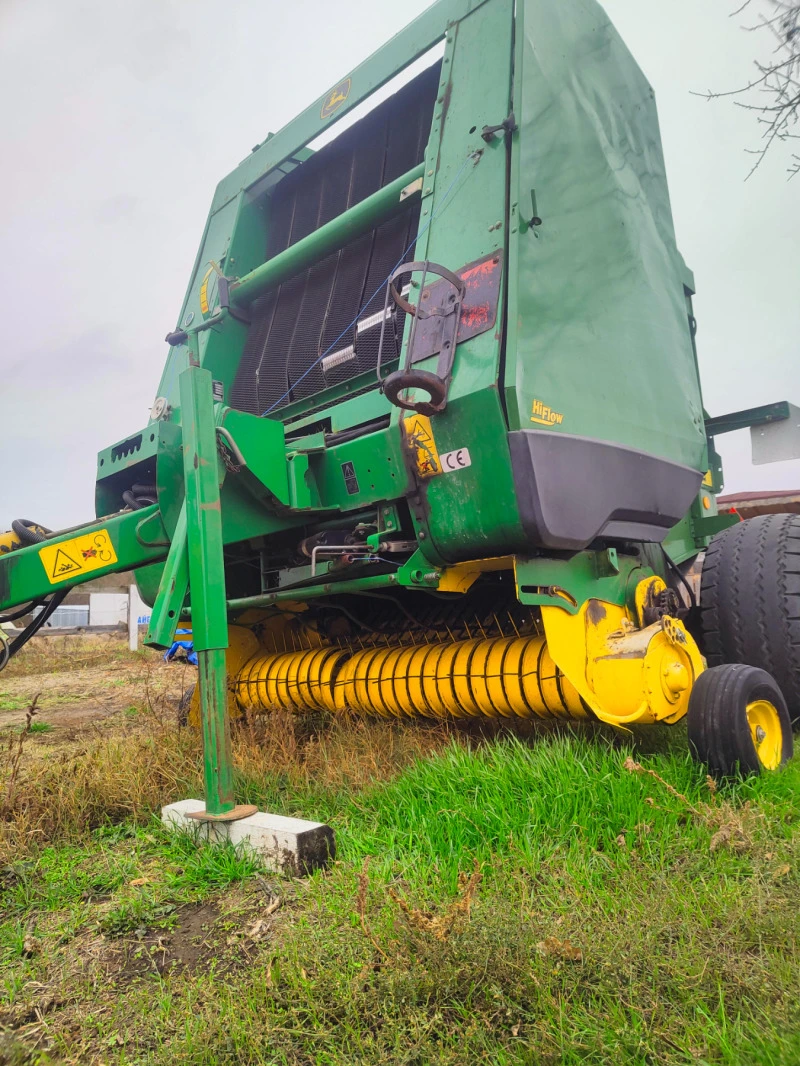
[{"xmin": 180, "ymin": 366, "xmax": 235, "ymax": 818}]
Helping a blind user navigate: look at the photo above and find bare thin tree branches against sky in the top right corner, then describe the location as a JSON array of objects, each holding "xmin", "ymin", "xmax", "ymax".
[{"xmin": 692, "ymin": 0, "xmax": 800, "ymax": 178}]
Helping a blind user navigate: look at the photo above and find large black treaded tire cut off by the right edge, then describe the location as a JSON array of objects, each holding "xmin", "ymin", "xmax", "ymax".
[{"xmin": 700, "ymin": 515, "xmax": 800, "ymax": 728}]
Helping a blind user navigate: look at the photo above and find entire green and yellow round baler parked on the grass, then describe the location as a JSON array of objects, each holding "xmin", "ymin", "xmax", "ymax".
[{"xmin": 0, "ymin": 0, "xmax": 800, "ymax": 817}]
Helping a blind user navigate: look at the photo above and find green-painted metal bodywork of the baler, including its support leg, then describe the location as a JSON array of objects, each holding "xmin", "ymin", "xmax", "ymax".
[{"xmin": 0, "ymin": 0, "xmax": 781, "ymax": 797}]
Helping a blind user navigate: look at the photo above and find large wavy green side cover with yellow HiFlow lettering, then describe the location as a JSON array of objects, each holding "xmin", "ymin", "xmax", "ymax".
[{"xmin": 506, "ymin": 0, "xmax": 706, "ymax": 471}]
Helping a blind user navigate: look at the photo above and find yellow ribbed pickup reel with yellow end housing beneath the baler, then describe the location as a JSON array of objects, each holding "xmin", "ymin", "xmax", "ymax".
[{"xmin": 234, "ymin": 578, "xmax": 703, "ymax": 725}]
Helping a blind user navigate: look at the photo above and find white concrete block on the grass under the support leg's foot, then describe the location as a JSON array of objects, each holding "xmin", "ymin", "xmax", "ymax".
[{"xmin": 161, "ymin": 800, "xmax": 336, "ymax": 877}]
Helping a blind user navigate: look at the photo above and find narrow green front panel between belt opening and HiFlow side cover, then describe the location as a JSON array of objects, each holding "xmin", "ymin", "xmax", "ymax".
[{"xmin": 396, "ymin": 0, "xmax": 524, "ymax": 562}]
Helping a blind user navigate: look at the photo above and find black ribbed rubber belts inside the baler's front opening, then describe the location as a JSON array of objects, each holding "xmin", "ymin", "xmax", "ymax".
[{"xmin": 231, "ymin": 57, "xmax": 441, "ymax": 414}]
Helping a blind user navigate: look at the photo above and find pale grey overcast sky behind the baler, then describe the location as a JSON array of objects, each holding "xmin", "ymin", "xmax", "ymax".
[{"xmin": 0, "ymin": 0, "xmax": 800, "ymax": 529}]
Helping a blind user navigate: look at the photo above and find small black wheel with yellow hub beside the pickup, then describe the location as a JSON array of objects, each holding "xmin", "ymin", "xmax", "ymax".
[{"xmin": 687, "ymin": 663, "xmax": 793, "ymax": 777}]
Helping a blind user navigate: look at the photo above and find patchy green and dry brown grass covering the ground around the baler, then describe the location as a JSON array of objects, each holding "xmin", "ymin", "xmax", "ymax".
[{"xmin": 0, "ymin": 635, "xmax": 800, "ymax": 1066}]
